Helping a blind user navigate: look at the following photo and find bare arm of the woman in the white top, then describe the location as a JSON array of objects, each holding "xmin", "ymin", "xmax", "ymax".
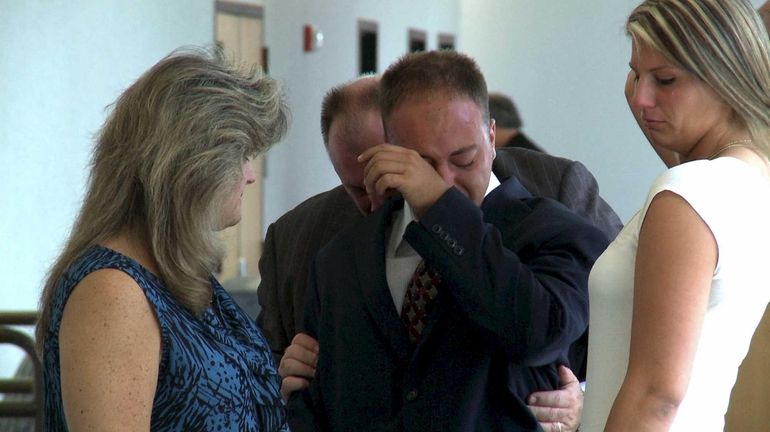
[{"xmin": 605, "ymin": 191, "xmax": 717, "ymax": 431}]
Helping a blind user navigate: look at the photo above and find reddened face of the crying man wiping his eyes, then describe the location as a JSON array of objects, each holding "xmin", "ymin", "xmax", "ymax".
[{"xmin": 386, "ymin": 95, "xmax": 495, "ymax": 206}]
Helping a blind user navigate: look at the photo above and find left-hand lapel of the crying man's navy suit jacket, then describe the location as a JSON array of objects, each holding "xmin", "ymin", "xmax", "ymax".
[{"xmin": 354, "ymin": 200, "xmax": 412, "ymax": 362}]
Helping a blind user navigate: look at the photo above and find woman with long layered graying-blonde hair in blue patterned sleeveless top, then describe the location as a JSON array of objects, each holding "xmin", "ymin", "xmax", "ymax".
[{"xmin": 37, "ymin": 51, "xmax": 288, "ymax": 431}]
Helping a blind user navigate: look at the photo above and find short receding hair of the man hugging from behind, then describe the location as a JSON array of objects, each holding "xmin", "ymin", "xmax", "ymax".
[{"xmin": 321, "ymin": 75, "xmax": 380, "ymax": 146}]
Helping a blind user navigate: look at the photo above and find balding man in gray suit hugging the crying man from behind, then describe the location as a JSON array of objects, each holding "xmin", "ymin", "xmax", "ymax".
[{"xmin": 258, "ymin": 77, "xmax": 622, "ymax": 430}]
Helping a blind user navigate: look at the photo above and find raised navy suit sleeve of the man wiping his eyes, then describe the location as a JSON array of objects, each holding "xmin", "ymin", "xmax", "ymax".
[{"xmin": 405, "ymin": 188, "xmax": 608, "ymax": 366}]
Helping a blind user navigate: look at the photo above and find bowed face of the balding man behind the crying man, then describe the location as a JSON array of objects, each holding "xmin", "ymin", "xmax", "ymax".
[{"xmin": 328, "ymin": 110, "xmax": 385, "ymax": 214}]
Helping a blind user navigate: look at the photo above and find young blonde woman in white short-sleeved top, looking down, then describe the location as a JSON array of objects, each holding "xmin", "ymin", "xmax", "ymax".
[{"xmin": 581, "ymin": 0, "xmax": 770, "ymax": 432}]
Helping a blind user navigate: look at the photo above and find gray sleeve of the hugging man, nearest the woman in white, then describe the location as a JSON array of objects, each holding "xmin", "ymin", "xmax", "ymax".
[{"xmin": 558, "ymin": 161, "xmax": 623, "ymax": 239}]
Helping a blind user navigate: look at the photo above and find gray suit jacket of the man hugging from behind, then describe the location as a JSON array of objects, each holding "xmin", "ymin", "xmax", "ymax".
[{"xmin": 257, "ymin": 148, "xmax": 623, "ymax": 363}]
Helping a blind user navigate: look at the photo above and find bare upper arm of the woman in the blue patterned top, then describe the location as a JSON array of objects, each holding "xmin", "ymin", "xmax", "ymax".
[{"xmin": 59, "ymin": 270, "xmax": 160, "ymax": 432}]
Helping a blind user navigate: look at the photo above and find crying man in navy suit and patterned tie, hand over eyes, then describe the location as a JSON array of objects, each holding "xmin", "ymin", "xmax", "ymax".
[{"xmin": 290, "ymin": 52, "xmax": 607, "ymax": 430}]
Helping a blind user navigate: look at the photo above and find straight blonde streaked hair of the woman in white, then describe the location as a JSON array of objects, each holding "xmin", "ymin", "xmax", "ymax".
[{"xmin": 626, "ymin": 0, "xmax": 770, "ymax": 155}]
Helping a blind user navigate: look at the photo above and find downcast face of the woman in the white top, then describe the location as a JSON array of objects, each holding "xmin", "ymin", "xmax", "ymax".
[{"xmin": 626, "ymin": 42, "xmax": 731, "ymax": 159}]
